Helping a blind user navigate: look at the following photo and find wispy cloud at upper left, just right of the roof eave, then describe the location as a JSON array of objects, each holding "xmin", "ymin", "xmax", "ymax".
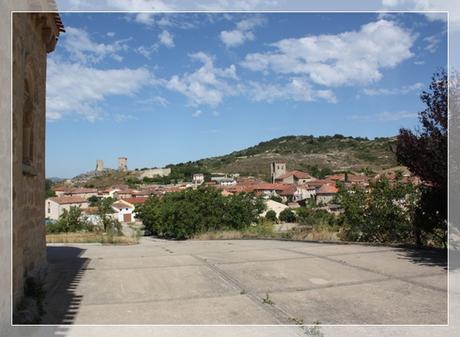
[{"xmin": 60, "ymin": 27, "xmax": 128, "ymax": 63}]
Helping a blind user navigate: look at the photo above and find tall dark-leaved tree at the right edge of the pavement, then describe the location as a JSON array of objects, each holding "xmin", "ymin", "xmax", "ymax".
[{"xmin": 396, "ymin": 71, "xmax": 448, "ymax": 244}]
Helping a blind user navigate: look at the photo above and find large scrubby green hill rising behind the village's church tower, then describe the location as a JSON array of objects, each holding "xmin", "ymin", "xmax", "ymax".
[{"xmin": 183, "ymin": 135, "xmax": 397, "ymax": 177}]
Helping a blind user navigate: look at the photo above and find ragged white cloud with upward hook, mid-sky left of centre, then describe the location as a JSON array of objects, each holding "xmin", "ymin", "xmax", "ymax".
[{"xmin": 166, "ymin": 52, "xmax": 238, "ymax": 107}]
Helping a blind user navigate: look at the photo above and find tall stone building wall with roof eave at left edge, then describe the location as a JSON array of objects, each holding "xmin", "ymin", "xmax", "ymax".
[{"xmin": 12, "ymin": 13, "xmax": 59, "ymax": 308}]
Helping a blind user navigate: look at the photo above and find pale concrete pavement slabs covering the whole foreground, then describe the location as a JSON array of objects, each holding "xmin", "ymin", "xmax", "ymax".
[{"xmin": 42, "ymin": 238, "xmax": 447, "ymax": 324}]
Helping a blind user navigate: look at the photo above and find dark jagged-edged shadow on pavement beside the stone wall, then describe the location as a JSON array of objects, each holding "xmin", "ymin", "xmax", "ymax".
[{"xmin": 41, "ymin": 246, "xmax": 90, "ymax": 324}]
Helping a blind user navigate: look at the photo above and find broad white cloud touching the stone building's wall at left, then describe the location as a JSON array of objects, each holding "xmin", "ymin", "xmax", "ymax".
[{"xmin": 46, "ymin": 58, "xmax": 152, "ymax": 121}]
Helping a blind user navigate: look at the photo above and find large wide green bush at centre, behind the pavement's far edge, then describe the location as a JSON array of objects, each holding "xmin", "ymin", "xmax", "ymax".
[{"xmin": 136, "ymin": 187, "xmax": 265, "ymax": 240}]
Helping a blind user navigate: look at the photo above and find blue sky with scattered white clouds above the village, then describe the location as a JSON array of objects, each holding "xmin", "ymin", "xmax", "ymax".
[{"xmin": 46, "ymin": 13, "xmax": 447, "ymax": 177}]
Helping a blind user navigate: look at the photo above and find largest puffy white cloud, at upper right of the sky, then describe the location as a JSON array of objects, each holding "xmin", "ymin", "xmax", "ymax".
[{"xmin": 241, "ymin": 20, "xmax": 414, "ymax": 86}]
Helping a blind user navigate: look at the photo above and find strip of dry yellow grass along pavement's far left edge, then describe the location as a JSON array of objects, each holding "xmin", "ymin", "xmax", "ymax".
[{"xmin": 46, "ymin": 232, "xmax": 139, "ymax": 245}]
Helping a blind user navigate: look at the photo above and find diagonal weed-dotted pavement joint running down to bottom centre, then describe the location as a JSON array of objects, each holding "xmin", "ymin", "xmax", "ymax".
[{"xmin": 191, "ymin": 255, "xmax": 292, "ymax": 324}]
